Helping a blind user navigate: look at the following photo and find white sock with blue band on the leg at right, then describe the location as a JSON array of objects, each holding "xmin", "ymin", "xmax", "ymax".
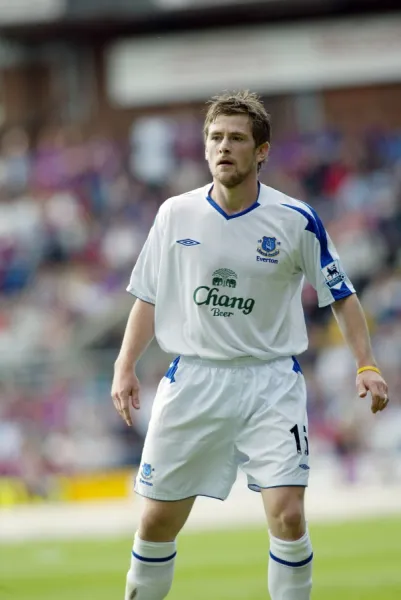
[{"xmin": 268, "ymin": 531, "xmax": 313, "ymax": 600}]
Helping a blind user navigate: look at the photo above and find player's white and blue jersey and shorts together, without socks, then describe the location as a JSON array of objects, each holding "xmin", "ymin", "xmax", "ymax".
[{"xmin": 127, "ymin": 184, "xmax": 355, "ymax": 500}]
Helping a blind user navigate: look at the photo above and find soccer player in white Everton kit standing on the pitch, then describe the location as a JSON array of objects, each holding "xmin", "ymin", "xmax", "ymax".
[{"xmin": 111, "ymin": 91, "xmax": 388, "ymax": 600}]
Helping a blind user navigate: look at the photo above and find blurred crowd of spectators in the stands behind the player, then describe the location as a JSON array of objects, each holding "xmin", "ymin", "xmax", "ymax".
[{"xmin": 0, "ymin": 114, "xmax": 401, "ymax": 495}]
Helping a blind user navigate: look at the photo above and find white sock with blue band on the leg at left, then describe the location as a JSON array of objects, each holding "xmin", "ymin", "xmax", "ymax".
[{"xmin": 125, "ymin": 534, "xmax": 177, "ymax": 600}]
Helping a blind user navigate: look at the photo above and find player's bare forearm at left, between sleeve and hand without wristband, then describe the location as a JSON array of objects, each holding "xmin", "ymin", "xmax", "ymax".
[{"xmin": 116, "ymin": 299, "xmax": 155, "ymax": 368}]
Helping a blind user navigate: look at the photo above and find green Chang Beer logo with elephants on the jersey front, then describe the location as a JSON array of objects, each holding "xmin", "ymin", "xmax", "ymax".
[{"xmin": 193, "ymin": 269, "xmax": 255, "ymax": 317}]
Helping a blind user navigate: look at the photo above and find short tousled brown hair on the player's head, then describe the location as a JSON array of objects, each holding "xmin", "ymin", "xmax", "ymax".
[{"xmin": 203, "ymin": 90, "xmax": 271, "ymax": 147}]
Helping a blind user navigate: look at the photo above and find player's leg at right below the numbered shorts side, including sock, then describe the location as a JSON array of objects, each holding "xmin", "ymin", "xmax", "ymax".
[{"xmin": 262, "ymin": 487, "xmax": 313, "ymax": 600}]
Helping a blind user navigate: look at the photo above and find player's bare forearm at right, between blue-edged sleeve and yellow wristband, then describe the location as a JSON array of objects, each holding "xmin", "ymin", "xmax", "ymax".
[{"xmin": 332, "ymin": 294, "xmax": 376, "ymax": 368}]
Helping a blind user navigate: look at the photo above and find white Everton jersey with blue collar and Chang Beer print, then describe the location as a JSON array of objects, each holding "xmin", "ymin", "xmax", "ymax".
[{"xmin": 127, "ymin": 184, "xmax": 355, "ymax": 360}]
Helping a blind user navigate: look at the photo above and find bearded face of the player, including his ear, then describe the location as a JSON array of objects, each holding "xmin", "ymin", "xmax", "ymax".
[{"xmin": 206, "ymin": 115, "xmax": 269, "ymax": 188}]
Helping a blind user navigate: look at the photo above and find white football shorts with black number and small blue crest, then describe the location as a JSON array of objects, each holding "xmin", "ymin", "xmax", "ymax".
[{"xmin": 135, "ymin": 357, "xmax": 309, "ymax": 501}]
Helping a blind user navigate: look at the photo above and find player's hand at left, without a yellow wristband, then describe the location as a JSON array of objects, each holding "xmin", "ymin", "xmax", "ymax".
[{"xmin": 111, "ymin": 363, "xmax": 140, "ymax": 427}]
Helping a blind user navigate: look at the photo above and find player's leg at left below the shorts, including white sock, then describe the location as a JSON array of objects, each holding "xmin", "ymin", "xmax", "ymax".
[{"xmin": 125, "ymin": 498, "xmax": 195, "ymax": 600}]
